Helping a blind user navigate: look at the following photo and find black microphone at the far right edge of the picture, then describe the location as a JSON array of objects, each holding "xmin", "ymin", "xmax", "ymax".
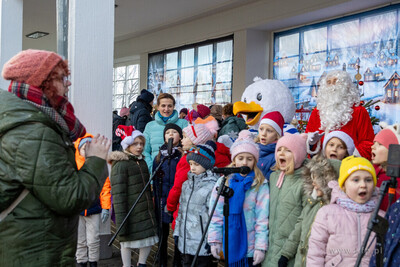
[{"xmin": 386, "ymin": 144, "xmax": 400, "ymax": 204}]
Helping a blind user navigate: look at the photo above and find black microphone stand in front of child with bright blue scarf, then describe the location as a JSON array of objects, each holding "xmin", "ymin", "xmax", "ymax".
[{"xmin": 191, "ymin": 175, "xmax": 234, "ymax": 267}]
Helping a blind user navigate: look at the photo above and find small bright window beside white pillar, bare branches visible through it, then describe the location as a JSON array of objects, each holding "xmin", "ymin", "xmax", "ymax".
[{"xmin": 113, "ymin": 64, "xmax": 140, "ymax": 113}]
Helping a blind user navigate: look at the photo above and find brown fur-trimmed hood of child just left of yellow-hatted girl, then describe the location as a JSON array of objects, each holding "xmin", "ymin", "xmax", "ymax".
[{"xmin": 303, "ymin": 155, "xmax": 341, "ymax": 204}]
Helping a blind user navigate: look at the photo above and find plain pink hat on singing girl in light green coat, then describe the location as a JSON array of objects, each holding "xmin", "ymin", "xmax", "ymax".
[{"xmin": 275, "ymin": 133, "xmax": 307, "ymax": 169}]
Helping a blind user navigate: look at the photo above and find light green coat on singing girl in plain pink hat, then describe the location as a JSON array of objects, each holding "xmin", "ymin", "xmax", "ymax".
[{"xmin": 262, "ymin": 163, "xmax": 307, "ymax": 267}]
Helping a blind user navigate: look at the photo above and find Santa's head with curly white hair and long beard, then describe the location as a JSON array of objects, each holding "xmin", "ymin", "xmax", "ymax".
[{"xmin": 317, "ymin": 70, "xmax": 360, "ymax": 132}]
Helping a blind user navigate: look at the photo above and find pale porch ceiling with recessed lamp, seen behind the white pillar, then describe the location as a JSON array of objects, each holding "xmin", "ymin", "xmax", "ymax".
[{"xmin": 23, "ymin": 0, "xmax": 258, "ymax": 50}]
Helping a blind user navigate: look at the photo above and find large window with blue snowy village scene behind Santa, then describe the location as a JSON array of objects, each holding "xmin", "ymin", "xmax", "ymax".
[{"xmin": 273, "ymin": 5, "xmax": 400, "ymax": 124}]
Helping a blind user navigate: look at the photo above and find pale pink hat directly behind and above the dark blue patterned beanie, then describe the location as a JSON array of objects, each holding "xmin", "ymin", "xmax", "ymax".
[{"xmin": 183, "ymin": 119, "xmax": 219, "ymax": 145}]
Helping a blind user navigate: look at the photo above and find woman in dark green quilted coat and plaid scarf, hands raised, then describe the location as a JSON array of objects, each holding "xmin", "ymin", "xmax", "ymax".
[{"xmin": 0, "ymin": 50, "xmax": 111, "ymax": 266}]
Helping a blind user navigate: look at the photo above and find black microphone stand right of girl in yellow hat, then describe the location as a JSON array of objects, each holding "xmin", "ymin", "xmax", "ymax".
[{"xmin": 354, "ymin": 180, "xmax": 390, "ymax": 267}]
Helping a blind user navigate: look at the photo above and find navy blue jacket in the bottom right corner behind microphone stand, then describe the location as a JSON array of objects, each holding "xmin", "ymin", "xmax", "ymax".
[{"xmin": 369, "ymin": 199, "xmax": 400, "ymax": 267}]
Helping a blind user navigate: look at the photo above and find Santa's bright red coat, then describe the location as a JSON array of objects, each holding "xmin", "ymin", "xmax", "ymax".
[{"xmin": 306, "ymin": 106, "xmax": 375, "ymax": 160}]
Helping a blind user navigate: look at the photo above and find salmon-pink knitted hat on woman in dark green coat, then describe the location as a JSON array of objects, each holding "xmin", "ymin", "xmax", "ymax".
[{"xmin": 2, "ymin": 49, "xmax": 63, "ymax": 87}]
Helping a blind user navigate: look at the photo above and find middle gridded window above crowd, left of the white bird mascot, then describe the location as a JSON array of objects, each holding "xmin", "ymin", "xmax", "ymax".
[{"xmin": 147, "ymin": 36, "xmax": 233, "ymax": 110}]
